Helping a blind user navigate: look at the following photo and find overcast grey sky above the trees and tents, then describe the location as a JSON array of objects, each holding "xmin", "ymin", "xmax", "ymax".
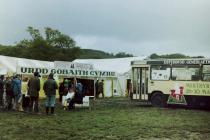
[{"xmin": 0, "ymin": 0, "xmax": 210, "ymax": 57}]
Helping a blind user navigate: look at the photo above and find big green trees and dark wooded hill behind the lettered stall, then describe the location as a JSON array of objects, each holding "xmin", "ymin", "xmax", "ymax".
[{"xmin": 0, "ymin": 26, "xmax": 133, "ymax": 61}]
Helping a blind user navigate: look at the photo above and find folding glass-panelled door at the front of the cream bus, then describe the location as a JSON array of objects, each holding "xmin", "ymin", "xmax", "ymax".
[{"xmin": 132, "ymin": 67, "xmax": 148, "ymax": 100}]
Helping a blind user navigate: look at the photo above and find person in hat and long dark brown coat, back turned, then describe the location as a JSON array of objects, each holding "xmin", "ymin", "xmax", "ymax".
[{"xmin": 28, "ymin": 72, "xmax": 40, "ymax": 113}]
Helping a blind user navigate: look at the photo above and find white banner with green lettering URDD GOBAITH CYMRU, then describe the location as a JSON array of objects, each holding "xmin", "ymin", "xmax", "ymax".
[{"xmin": 17, "ymin": 67, "xmax": 116, "ymax": 77}]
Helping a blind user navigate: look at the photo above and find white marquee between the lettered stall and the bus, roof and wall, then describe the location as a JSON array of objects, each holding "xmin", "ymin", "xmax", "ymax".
[{"xmin": 73, "ymin": 56, "xmax": 146, "ymax": 96}]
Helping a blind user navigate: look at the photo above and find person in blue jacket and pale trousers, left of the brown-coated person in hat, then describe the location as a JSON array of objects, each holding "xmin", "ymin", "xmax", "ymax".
[{"xmin": 12, "ymin": 75, "xmax": 23, "ymax": 111}]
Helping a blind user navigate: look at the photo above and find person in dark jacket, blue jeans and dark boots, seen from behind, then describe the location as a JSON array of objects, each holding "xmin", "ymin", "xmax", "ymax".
[{"xmin": 43, "ymin": 73, "xmax": 58, "ymax": 115}]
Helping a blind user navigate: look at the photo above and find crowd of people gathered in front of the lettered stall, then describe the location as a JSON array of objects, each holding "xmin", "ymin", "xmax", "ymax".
[{"xmin": 0, "ymin": 72, "xmax": 84, "ymax": 115}]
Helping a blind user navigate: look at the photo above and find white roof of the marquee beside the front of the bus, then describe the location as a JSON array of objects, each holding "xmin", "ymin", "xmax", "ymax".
[{"xmin": 73, "ymin": 56, "xmax": 146, "ymax": 74}]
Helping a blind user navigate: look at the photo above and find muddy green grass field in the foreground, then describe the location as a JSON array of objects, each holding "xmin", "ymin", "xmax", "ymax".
[{"xmin": 0, "ymin": 99, "xmax": 210, "ymax": 140}]
